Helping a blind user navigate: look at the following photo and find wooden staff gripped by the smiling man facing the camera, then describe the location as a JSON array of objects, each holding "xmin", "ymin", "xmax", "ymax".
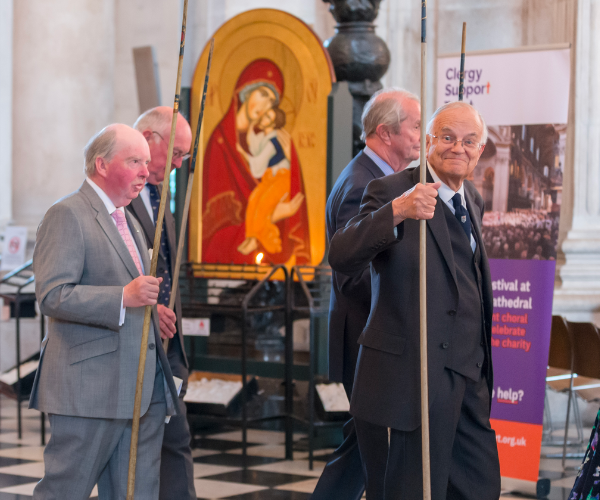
[{"xmin": 419, "ymin": 0, "xmax": 431, "ymax": 500}]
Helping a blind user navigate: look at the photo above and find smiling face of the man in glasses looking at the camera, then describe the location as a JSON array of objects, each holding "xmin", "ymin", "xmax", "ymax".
[{"xmin": 426, "ymin": 108, "xmax": 484, "ymax": 190}]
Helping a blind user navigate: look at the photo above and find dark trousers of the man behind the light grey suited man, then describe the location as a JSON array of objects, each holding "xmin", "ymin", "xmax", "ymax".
[{"xmin": 159, "ymin": 344, "xmax": 196, "ymax": 500}]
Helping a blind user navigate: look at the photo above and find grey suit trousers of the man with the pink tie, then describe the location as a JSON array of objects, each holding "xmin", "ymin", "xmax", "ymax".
[{"xmin": 33, "ymin": 363, "xmax": 167, "ymax": 500}]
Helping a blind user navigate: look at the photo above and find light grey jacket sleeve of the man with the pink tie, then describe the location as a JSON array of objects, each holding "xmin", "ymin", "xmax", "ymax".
[{"xmin": 33, "ymin": 204, "xmax": 123, "ymax": 331}]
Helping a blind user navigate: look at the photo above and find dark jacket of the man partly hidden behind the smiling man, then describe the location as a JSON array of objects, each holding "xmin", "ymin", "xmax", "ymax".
[{"xmin": 326, "ymin": 152, "xmax": 383, "ymax": 385}]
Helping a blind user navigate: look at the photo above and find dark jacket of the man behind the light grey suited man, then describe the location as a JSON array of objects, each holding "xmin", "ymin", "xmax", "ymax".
[{"xmin": 127, "ymin": 185, "xmax": 189, "ymax": 374}]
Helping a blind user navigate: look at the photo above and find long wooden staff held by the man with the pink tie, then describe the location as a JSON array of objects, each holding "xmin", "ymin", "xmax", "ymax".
[{"xmin": 127, "ymin": 0, "xmax": 188, "ymax": 500}]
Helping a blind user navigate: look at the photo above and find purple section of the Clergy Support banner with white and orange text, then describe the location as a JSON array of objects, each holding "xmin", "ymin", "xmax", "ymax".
[{"xmin": 490, "ymin": 259, "xmax": 556, "ymax": 425}]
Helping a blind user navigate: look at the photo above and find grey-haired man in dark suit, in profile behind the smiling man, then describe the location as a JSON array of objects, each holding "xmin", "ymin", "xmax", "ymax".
[{"xmin": 312, "ymin": 88, "xmax": 421, "ymax": 500}]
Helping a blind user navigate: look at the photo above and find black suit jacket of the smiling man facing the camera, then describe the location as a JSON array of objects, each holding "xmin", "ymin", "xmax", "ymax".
[{"xmin": 329, "ymin": 168, "xmax": 493, "ymax": 431}]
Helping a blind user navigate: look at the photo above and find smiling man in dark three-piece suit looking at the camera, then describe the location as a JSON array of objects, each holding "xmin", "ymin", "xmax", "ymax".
[{"xmin": 329, "ymin": 102, "xmax": 500, "ymax": 500}]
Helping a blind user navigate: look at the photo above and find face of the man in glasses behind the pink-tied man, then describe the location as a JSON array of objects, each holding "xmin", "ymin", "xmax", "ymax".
[{"xmin": 144, "ymin": 117, "xmax": 192, "ymax": 185}]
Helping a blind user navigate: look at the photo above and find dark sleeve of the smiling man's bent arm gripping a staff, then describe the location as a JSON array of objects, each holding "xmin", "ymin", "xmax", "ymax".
[{"xmin": 329, "ymin": 179, "xmax": 404, "ymax": 275}]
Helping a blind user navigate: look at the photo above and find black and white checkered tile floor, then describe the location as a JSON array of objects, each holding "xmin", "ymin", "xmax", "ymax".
[{"xmin": 0, "ymin": 396, "xmax": 589, "ymax": 500}]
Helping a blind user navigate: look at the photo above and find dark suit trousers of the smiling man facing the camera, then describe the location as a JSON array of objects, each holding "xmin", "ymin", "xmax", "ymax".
[{"xmin": 355, "ymin": 369, "xmax": 500, "ymax": 500}]
